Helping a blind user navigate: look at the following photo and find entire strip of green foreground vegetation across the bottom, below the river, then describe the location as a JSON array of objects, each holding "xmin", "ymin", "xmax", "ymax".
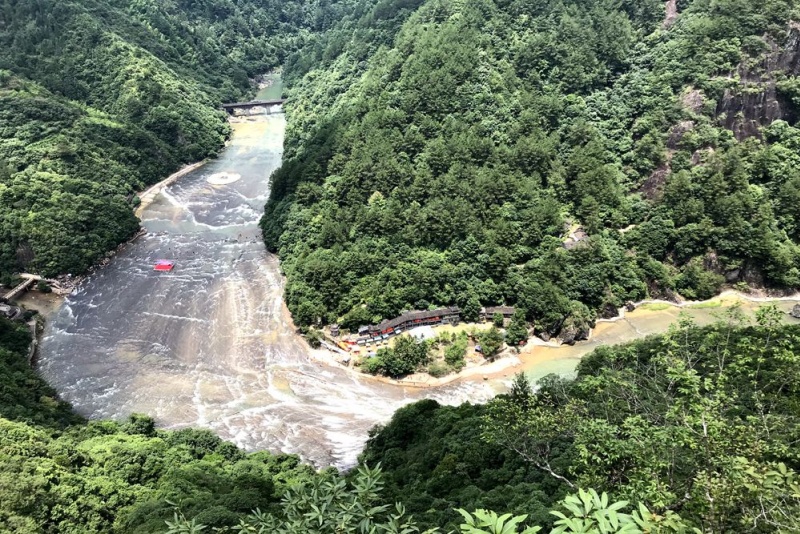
[{"xmin": 0, "ymin": 307, "xmax": 800, "ymax": 534}]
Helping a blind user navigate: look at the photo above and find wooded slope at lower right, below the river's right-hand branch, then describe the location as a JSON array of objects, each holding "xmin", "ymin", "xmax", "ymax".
[{"xmin": 361, "ymin": 307, "xmax": 800, "ymax": 533}]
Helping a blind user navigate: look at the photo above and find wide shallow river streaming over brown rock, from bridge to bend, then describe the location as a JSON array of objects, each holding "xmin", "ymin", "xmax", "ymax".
[{"xmin": 39, "ymin": 115, "xmax": 493, "ymax": 467}]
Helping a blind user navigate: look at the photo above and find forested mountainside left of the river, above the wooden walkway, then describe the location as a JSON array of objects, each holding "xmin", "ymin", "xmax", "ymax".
[{"xmin": 0, "ymin": 0, "xmax": 348, "ymax": 278}]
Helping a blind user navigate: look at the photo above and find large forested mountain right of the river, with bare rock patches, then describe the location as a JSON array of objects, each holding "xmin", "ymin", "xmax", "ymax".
[{"xmin": 262, "ymin": 0, "xmax": 800, "ymax": 335}]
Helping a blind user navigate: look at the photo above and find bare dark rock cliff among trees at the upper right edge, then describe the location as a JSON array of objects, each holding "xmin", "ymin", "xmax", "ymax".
[{"xmin": 716, "ymin": 23, "xmax": 800, "ymax": 141}]
